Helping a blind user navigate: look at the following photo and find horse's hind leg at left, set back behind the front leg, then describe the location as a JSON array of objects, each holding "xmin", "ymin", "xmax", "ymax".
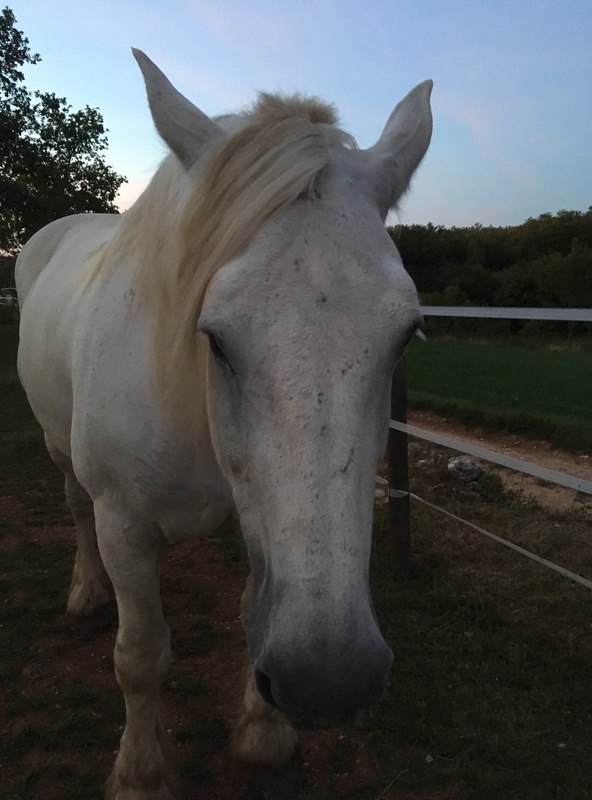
[{"xmin": 45, "ymin": 434, "xmax": 112, "ymax": 633}]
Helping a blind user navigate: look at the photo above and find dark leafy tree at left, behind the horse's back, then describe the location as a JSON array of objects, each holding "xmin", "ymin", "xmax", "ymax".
[{"xmin": 0, "ymin": 8, "xmax": 125, "ymax": 255}]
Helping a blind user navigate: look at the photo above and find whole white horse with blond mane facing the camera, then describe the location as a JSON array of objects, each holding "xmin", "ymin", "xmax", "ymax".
[{"xmin": 17, "ymin": 51, "xmax": 432, "ymax": 800}]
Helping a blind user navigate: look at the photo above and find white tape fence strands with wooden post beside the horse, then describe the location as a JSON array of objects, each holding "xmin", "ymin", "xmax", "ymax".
[{"xmin": 387, "ymin": 306, "xmax": 592, "ymax": 589}]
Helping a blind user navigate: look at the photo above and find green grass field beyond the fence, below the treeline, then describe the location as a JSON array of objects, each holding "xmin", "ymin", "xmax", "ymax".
[{"xmin": 407, "ymin": 339, "xmax": 592, "ymax": 452}]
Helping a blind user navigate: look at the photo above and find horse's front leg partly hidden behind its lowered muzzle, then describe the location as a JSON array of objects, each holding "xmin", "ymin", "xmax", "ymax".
[{"xmin": 232, "ymin": 576, "xmax": 302, "ymax": 800}]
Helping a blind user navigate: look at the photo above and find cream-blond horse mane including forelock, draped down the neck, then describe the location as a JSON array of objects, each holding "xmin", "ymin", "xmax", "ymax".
[{"xmin": 93, "ymin": 93, "xmax": 355, "ymax": 438}]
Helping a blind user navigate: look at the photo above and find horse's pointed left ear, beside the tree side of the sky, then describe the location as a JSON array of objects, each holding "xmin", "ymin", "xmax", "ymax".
[{"xmin": 132, "ymin": 47, "xmax": 224, "ymax": 168}]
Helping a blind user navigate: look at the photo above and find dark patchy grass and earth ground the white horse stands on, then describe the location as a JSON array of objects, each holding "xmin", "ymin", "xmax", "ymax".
[{"xmin": 0, "ymin": 326, "xmax": 592, "ymax": 800}]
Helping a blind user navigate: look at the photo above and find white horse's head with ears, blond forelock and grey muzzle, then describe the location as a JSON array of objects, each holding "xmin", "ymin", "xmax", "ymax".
[{"xmin": 136, "ymin": 52, "xmax": 431, "ymax": 726}]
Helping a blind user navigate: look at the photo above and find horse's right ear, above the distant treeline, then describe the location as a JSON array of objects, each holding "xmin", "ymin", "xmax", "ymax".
[{"xmin": 366, "ymin": 81, "xmax": 433, "ymax": 216}]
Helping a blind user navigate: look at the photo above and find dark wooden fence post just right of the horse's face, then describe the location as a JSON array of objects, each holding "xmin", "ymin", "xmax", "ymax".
[{"xmin": 387, "ymin": 355, "xmax": 411, "ymax": 578}]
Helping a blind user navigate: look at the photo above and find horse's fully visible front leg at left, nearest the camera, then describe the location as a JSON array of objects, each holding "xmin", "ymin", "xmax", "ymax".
[{"xmin": 95, "ymin": 500, "xmax": 173, "ymax": 800}]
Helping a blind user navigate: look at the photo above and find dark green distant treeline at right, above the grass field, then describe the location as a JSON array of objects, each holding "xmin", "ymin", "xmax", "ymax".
[{"xmin": 389, "ymin": 206, "xmax": 592, "ymax": 318}]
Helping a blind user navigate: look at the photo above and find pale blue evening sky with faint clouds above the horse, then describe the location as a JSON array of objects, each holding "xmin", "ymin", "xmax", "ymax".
[{"xmin": 8, "ymin": 0, "xmax": 592, "ymax": 227}]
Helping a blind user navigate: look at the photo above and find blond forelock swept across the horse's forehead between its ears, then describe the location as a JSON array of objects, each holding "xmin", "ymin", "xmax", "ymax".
[{"xmin": 177, "ymin": 93, "xmax": 354, "ymax": 315}]
